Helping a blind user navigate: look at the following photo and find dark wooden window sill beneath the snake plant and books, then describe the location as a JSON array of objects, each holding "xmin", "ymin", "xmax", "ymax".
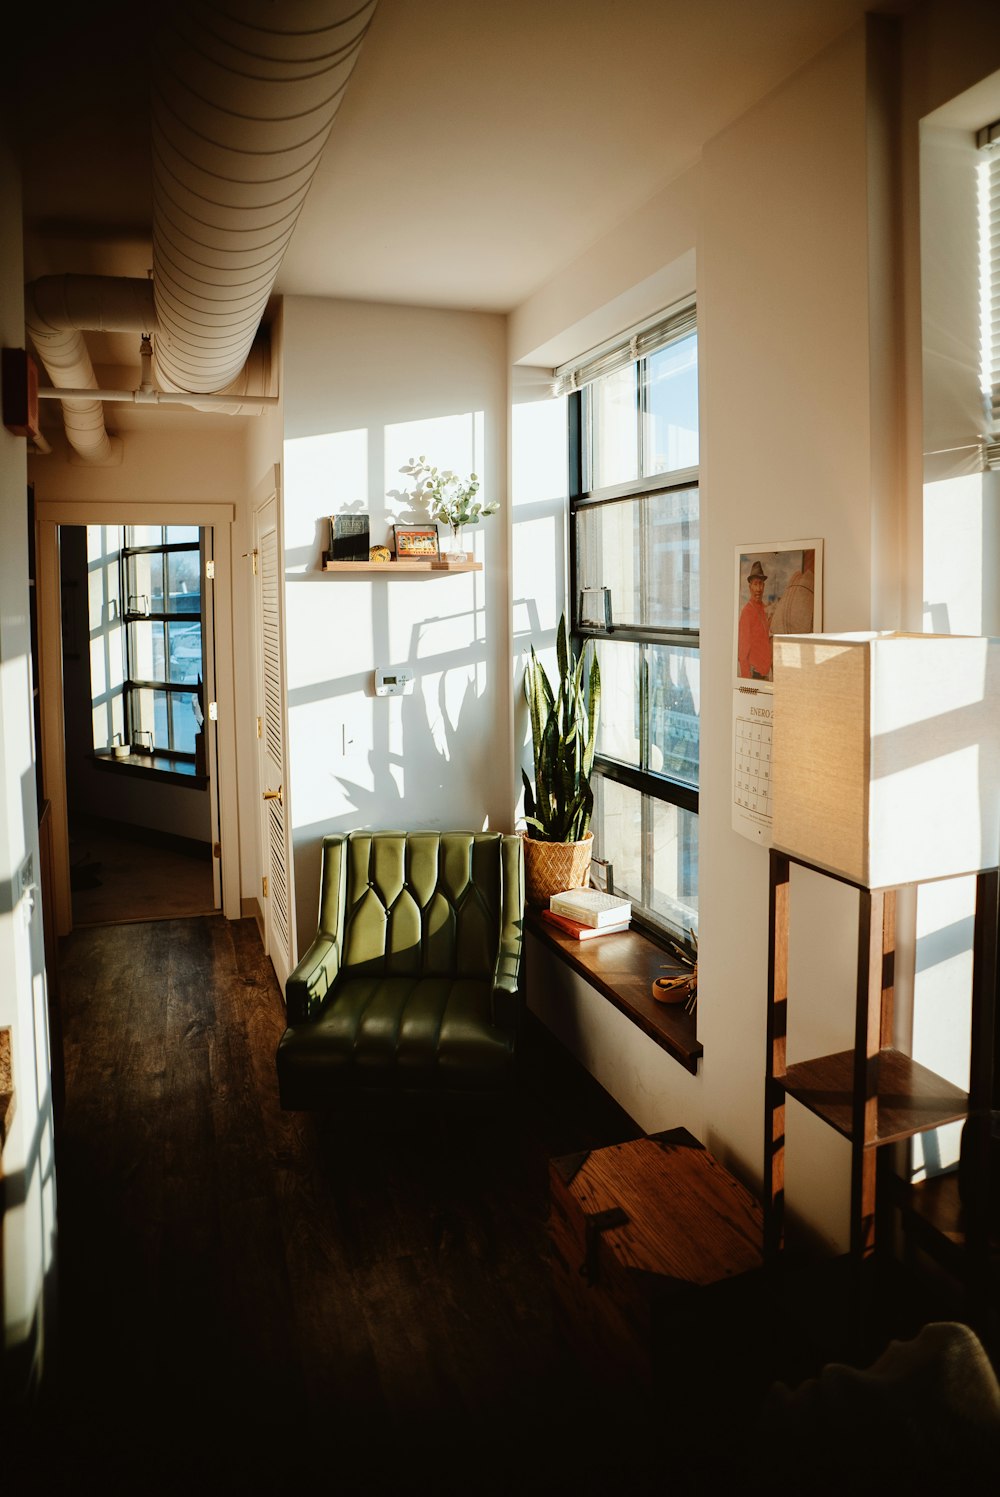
[{"xmin": 524, "ymin": 910, "xmax": 704, "ymax": 1075}]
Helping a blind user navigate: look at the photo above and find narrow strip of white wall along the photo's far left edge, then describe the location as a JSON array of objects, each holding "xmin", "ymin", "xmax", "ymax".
[{"xmin": 0, "ymin": 132, "xmax": 55, "ymax": 1418}]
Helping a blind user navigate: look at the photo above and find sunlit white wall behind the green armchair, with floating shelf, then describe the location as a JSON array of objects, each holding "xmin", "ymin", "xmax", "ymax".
[{"xmin": 283, "ymin": 298, "xmax": 512, "ymax": 949}]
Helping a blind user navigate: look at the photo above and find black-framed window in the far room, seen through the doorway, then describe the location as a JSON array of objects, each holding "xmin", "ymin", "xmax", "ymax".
[{"xmin": 88, "ymin": 525, "xmax": 204, "ymax": 775}]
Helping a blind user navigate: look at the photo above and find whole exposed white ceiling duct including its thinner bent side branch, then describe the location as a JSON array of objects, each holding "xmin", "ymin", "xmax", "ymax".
[{"xmin": 25, "ymin": 0, "xmax": 377, "ymax": 463}]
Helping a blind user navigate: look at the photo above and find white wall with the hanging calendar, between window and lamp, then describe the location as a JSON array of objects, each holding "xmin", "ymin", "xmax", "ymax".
[{"xmin": 698, "ymin": 25, "xmax": 895, "ymax": 1246}]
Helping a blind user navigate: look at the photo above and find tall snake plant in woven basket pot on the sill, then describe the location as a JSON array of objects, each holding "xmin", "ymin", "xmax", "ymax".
[{"xmin": 521, "ymin": 614, "xmax": 600, "ymax": 904}]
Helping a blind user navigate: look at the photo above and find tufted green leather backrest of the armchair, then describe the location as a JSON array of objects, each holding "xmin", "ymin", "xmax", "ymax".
[{"xmin": 320, "ymin": 832, "xmax": 516, "ymax": 978}]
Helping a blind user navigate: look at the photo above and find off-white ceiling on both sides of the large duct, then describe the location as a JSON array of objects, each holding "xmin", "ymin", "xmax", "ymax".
[{"xmin": 4, "ymin": 0, "xmax": 907, "ymax": 431}]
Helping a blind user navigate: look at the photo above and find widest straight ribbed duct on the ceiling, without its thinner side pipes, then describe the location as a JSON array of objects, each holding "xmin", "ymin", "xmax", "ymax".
[{"xmin": 153, "ymin": 0, "xmax": 376, "ymax": 394}]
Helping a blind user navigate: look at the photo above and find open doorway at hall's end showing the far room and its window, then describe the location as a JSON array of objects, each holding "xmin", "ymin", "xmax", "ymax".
[{"xmin": 60, "ymin": 524, "xmax": 215, "ymax": 927}]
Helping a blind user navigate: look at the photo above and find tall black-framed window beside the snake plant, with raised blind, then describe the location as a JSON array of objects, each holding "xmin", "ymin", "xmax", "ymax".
[{"xmin": 557, "ymin": 297, "xmax": 701, "ymax": 940}]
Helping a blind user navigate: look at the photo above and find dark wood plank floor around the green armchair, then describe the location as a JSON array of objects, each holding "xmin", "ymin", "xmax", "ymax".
[{"xmin": 10, "ymin": 916, "xmax": 994, "ymax": 1497}]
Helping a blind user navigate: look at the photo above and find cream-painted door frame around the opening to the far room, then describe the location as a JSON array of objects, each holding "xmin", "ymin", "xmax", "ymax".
[{"xmin": 34, "ymin": 499, "xmax": 243, "ymax": 936}]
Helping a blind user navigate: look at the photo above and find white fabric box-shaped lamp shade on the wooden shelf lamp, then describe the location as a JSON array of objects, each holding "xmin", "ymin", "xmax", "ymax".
[{"xmin": 771, "ymin": 633, "xmax": 1000, "ymax": 889}]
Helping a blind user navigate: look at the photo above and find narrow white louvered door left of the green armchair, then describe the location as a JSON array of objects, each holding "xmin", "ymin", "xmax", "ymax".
[{"xmin": 253, "ymin": 497, "xmax": 292, "ymax": 991}]
